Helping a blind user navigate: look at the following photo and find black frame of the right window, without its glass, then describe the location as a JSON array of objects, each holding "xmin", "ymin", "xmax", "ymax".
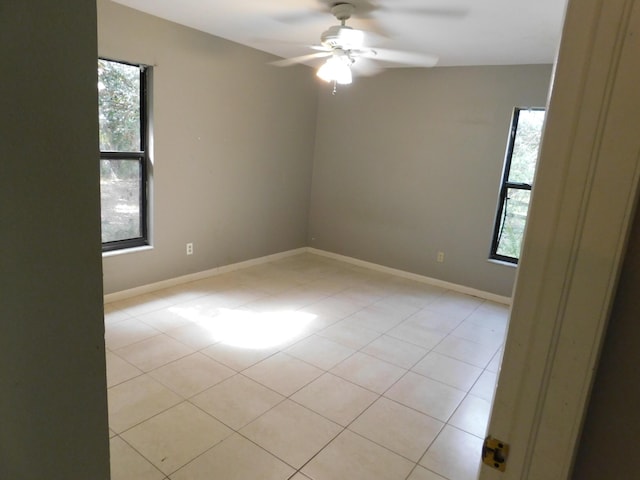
[{"xmin": 489, "ymin": 107, "xmax": 546, "ymax": 265}]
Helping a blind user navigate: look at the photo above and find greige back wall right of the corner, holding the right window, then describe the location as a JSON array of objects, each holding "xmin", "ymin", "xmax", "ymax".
[{"xmin": 309, "ymin": 65, "xmax": 551, "ymax": 296}]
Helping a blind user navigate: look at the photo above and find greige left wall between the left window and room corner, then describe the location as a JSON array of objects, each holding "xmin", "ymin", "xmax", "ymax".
[{"xmin": 98, "ymin": 0, "xmax": 317, "ymax": 293}]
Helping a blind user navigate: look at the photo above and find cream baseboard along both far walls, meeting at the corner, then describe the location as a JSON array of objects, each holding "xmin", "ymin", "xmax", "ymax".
[{"xmin": 104, "ymin": 247, "xmax": 511, "ymax": 305}]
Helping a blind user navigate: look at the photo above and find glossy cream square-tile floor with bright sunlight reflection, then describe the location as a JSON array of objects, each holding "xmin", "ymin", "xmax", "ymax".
[{"xmin": 105, "ymin": 254, "xmax": 507, "ymax": 480}]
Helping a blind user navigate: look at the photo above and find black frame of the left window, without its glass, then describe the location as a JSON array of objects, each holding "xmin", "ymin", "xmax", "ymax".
[{"xmin": 99, "ymin": 57, "xmax": 150, "ymax": 253}]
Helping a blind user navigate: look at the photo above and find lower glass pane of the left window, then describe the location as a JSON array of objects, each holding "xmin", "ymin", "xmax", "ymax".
[{"xmin": 100, "ymin": 159, "xmax": 142, "ymax": 242}]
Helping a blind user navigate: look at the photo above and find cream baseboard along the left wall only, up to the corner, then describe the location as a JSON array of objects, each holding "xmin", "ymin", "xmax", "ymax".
[{"xmin": 104, "ymin": 247, "xmax": 307, "ymax": 304}]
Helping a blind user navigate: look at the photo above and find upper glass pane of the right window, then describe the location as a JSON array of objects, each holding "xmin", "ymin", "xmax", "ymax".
[{"xmin": 508, "ymin": 110, "xmax": 545, "ymax": 185}]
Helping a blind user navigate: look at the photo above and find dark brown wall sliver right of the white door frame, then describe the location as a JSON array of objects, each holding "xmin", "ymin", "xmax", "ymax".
[{"xmin": 572, "ymin": 196, "xmax": 640, "ymax": 480}]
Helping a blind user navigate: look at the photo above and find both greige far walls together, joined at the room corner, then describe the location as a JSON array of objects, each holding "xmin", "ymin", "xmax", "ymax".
[{"xmin": 98, "ymin": 0, "xmax": 551, "ymax": 296}]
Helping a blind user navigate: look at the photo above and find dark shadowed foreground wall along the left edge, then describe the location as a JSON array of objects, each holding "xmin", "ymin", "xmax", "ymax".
[{"xmin": 0, "ymin": 0, "xmax": 109, "ymax": 480}]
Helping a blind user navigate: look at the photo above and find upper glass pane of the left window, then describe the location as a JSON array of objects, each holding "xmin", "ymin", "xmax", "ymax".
[{"xmin": 98, "ymin": 60, "xmax": 141, "ymax": 152}]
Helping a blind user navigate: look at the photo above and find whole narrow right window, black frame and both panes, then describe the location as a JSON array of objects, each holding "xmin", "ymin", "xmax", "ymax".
[{"xmin": 491, "ymin": 108, "xmax": 545, "ymax": 263}]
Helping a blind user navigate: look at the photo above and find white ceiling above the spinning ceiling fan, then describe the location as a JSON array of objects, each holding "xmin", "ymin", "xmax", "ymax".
[{"xmin": 115, "ymin": 0, "xmax": 566, "ymax": 66}]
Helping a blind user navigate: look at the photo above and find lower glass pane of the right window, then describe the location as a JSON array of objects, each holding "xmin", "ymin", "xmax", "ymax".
[{"xmin": 496, "ymin": 188, "xmax": 531, "ymax": 258}]
